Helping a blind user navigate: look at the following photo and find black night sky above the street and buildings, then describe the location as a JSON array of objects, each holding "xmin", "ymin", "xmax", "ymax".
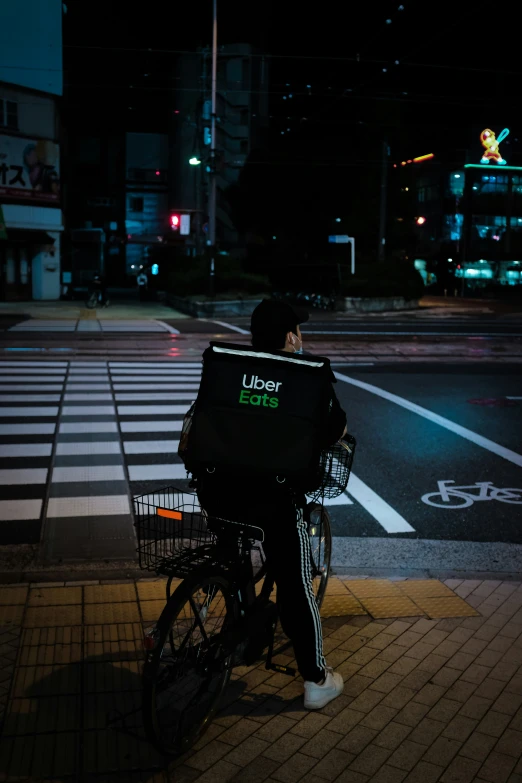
[{"xmin": 64, "ymin": 0, "xmax": 522, "ymax": 251}]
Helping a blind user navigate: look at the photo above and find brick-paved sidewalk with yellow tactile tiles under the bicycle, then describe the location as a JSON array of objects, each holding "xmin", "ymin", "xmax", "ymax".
[{"xmin": 0, "ymin": 579, "xmax": 522, "ymax": 783}]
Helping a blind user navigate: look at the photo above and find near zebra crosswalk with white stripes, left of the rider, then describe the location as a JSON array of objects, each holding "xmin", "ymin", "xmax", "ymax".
[{"xmin": 0, "ymin": 360, "xmax": 352, "ymax": 559}]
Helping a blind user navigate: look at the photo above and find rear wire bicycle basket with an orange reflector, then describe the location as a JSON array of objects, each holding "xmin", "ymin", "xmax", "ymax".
[{"xmin": 134, "ymin": 487, "xmax": 216, "ymax": 577}]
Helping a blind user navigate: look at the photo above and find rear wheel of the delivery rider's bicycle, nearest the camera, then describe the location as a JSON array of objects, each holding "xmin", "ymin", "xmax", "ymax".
[{"xmin": 142, "ymin": 573, "xmax": 238, "ymax": 755}]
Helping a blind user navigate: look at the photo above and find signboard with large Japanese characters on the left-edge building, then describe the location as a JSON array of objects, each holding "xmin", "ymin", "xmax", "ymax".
[{"xmin": 0, "ymin": 135, "xmax": 60, "ymax": 203}]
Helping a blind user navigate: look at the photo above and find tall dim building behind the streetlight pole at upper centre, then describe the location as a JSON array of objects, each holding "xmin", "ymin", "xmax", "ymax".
[{"xmin": 170, "ymin": 44, "xmax": 269, "ymax": 253}]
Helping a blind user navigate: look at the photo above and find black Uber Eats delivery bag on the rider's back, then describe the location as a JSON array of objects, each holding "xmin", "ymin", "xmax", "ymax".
[{"xmin": 180, "ymin": 342, "xmax": 332, "ymax": 486}]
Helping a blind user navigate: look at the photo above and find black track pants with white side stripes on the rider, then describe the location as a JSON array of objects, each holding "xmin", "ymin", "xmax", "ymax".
[{"xmin": 198, "ymin": 477, "xmax": 326, "ymax": 682}]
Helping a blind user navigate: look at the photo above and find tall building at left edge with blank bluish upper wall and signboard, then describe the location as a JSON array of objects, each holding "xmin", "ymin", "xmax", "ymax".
[{"xmin": 0, "ymin": 0, "xmax": 63, "ymax": 301}]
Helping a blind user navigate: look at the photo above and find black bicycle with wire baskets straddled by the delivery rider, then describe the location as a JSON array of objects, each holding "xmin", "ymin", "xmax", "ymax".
[{"xmin": 134, "ymin": 436, "xmax": 356, "ymax": 755}]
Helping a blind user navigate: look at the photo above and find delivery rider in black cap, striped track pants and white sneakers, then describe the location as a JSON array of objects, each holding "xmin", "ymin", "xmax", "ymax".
[{"xmin": 197, "ymin": 300, "xmax": 346, "ymax": 709}]
